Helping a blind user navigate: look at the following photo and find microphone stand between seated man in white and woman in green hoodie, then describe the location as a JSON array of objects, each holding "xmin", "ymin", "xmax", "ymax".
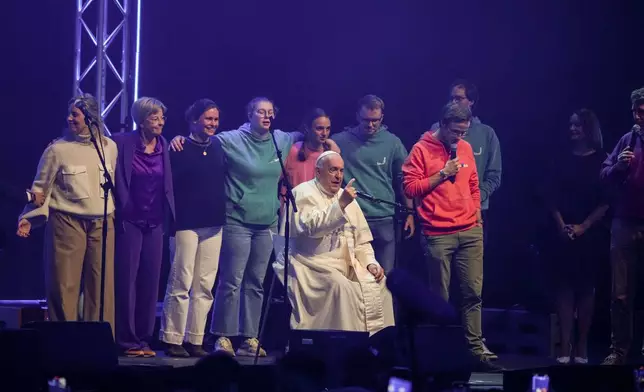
[{"xmin": 254, "ymin": 130, "xmax": 297, "ymax": 365}]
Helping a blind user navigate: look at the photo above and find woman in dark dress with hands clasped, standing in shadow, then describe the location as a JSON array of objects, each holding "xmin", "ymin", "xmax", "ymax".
[{"xmin": 549, "ymin": 109, "xmax": 608, "ymax": 364}]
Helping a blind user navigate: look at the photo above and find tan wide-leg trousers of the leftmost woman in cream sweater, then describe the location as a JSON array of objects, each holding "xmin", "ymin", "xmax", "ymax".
[{"xmin": 45, "ymin": 210, "xmax": 114, "ymax": 331}]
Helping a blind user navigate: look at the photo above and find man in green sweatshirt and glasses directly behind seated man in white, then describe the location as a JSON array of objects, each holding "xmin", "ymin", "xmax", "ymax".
[{"xmin": 332, "ymin": 95, "xmax": 415, "ymax": 273}]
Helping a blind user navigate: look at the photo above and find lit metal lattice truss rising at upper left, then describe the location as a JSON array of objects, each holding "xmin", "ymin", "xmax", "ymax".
[{"xmin": 73, "ymin": 0, "xmax": 135, "ymax": 134}]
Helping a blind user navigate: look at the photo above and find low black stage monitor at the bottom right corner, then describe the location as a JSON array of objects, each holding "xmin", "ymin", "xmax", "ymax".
[{"xmin": 503, "ymin": 365, "xmax": 641, "ymax": 392}]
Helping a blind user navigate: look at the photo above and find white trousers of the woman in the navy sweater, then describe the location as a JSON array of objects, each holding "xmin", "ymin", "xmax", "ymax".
[{"xmin": 159, "ymin": 226, "xmax": 222, "ymax": 345}]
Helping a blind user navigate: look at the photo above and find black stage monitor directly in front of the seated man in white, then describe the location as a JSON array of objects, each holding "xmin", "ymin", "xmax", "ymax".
[{"xmin": 288, "ymin": 329, "xmax": 369, "ymax": 388}]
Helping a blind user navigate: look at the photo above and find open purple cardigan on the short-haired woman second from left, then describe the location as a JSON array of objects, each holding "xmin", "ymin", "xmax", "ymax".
[{"xmin": 112, "ymin": 131, "xmax": 175, "ymax": 232}]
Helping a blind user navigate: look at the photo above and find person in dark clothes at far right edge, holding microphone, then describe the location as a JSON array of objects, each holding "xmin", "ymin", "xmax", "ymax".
[{"xmin": 601, "ymin": 87, "xmax": 644, "ymax": 365}]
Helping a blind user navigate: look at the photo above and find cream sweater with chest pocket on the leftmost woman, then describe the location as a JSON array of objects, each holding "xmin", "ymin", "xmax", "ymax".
[{"xmin": 20, "ymin": 135, "xmax": 117, "ymax": 226}]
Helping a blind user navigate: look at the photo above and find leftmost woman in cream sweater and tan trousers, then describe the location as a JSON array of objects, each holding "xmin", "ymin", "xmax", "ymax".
[{"xmin": 17, "ymin": 94, "xmax": 117, "ymax": 327}]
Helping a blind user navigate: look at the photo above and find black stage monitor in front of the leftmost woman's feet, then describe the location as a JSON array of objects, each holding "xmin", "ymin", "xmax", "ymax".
[{"xmin": 24, "ymin": 321, "xmax": 118, "ymax": 377}]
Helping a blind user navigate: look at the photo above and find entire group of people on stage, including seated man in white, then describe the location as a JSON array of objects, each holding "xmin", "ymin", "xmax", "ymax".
[{"xmin": 12, "ymin": 80, "xmax": 644, "ymax": 363}]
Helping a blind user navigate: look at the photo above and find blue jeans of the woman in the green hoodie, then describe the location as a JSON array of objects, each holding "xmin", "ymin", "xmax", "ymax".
[{"xmin": 210, "ymin": 220, "xmax": 273, "ymax": 338}]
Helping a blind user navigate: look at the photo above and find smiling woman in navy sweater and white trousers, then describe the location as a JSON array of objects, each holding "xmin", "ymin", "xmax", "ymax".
[{"xmin": 159, "ymin": 99, "xmax": 226, "ymax": 357}]
